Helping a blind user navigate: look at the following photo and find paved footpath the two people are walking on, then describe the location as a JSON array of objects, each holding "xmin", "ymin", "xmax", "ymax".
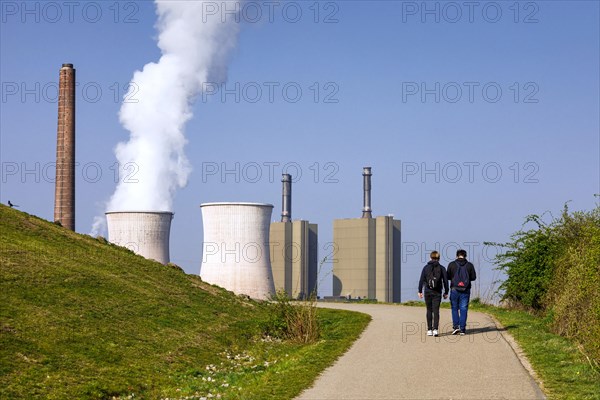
[{"xmin": 298, "ymin": 303, "xmax": 544, "ymax": 400}]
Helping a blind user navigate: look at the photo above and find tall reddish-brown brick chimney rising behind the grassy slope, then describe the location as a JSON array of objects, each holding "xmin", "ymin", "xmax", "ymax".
[{"xmin": 54, "ymin": 64, "xmax": 75, "ymax": 231}]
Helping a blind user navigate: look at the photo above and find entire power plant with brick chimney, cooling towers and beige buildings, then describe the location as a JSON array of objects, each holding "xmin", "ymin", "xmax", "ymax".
[{"xmin": 49, "ymin": 64, "xmax": 401, "ymax": 303}]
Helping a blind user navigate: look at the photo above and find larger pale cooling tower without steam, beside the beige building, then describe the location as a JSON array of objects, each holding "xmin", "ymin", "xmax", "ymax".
[{"xmin": 200, "ymin": 203, "xmax": 275, "ymax": 300}]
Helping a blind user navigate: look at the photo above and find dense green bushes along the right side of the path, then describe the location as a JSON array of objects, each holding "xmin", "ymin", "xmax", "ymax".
[{"xmin": 490, "ymin": 205, "xmax": 600, "ymax": 370}]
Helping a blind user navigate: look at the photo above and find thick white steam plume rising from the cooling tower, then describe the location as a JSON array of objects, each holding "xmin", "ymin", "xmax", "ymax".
[{"xmin": 108, "ymin": 1, "xmax": 239, "ymax": 211}]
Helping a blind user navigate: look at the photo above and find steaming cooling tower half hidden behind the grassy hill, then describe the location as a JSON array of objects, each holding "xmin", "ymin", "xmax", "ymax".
[{"xmin": 106, "ymin": 211, "xmax": 173, "ymax": 264}]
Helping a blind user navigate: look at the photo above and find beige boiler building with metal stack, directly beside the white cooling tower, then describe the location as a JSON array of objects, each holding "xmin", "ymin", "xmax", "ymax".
[{"xmin": 270, "ymin": 174, "xmax": 318, "ymax": 299}]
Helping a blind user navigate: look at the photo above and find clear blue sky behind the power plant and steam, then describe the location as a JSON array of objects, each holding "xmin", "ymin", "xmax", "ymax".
[{"xmin": 0, "ymin": 1, "xmax": 600, "ymax": 300}]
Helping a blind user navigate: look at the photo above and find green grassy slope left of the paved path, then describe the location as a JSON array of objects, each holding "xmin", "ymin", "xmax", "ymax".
[{"xmin": 0, "ymin": 206, "xmax": 368, "ymax": 399}]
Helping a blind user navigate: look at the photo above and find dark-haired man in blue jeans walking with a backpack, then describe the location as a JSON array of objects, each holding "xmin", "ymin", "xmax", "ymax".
[{"xmin": 448, "ymin": 249, "xmax": 477, "ymax": 335}]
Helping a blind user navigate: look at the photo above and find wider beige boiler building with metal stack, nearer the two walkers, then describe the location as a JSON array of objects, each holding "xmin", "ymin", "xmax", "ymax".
[{"xmin": 333, "ymin": 167, "xmax": 401, "ymax": 303}]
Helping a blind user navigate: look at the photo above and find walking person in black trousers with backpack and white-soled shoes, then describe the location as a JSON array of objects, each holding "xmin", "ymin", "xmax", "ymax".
[{"xmin": 419, "ymin": 251, "xmax": 448, "ymax": 336}]
